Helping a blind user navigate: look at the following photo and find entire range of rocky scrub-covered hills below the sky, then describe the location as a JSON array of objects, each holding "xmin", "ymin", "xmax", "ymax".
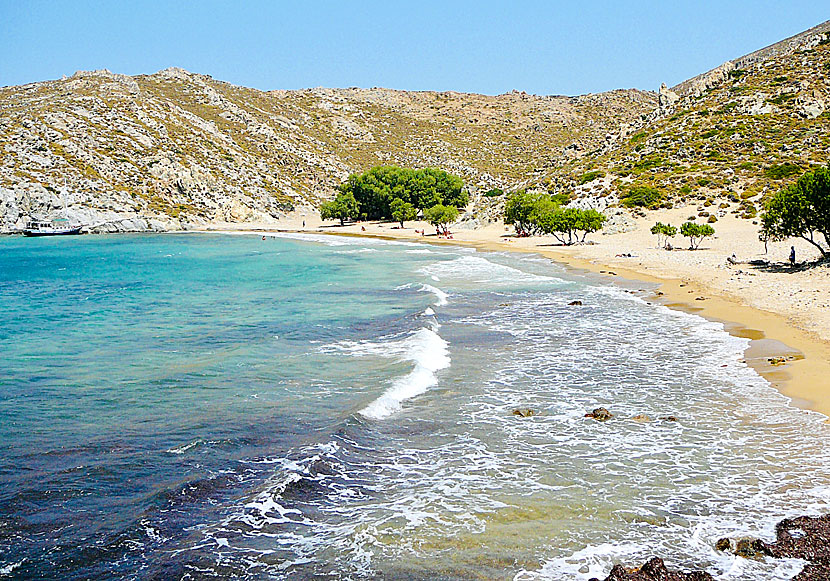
[{"xmin": 0, "ymin": 22, "xmax": 830, "ymax": 232}]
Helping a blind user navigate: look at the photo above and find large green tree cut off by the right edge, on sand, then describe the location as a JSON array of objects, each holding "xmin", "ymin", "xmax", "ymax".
[{"xmin": 761, "ymin": 167, "xmax": 830, "ymax": 256}]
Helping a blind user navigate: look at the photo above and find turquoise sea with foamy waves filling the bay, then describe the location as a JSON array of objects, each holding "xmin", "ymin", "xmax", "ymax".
[{"xmin": 0, "ymin": 234, "xmax": 830, "ymax": 579}]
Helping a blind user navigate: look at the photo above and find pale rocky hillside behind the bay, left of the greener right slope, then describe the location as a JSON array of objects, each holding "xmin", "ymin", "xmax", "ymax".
[{"xmin": 0, "ymin": 69, "xmax": 657, "ymax": 231}]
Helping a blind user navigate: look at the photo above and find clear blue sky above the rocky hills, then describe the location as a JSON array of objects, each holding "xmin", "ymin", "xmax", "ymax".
[{"xmin": 0, "ymin": 0, "xmax": 830, "ymax": 95}]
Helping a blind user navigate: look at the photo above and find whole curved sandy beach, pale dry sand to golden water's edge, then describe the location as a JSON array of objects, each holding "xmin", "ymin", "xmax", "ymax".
[{"xmin": 206, "ymin": 208, "xmax": 830, "ymax": 415}]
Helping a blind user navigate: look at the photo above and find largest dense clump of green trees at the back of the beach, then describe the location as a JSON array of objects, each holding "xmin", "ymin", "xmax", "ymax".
[{"xmin": 320, "ymin": 166, "xmax": 469, "ymax": 226}]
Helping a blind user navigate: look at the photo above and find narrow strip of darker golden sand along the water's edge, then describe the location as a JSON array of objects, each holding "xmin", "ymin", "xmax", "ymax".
[{"xmin": 199, "ymin": 220, "xmax": 830, "ymax": 422}]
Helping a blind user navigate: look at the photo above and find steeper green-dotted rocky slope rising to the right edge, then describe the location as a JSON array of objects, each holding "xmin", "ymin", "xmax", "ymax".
[{"xmin": 560, "ymin": 22, "xmax": 830, "ymax": 222}]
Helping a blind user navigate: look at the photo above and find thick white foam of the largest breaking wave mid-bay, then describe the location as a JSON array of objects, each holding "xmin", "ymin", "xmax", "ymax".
[{"xmin": 353, "ymin": 328, "xmax": 450, "ymax": 420}]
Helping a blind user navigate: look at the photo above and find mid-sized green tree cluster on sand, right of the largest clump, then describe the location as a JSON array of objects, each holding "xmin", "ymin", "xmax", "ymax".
[{"xmin": 504, "ymin": 190, "xmax": 606, "ymax": 245}]
